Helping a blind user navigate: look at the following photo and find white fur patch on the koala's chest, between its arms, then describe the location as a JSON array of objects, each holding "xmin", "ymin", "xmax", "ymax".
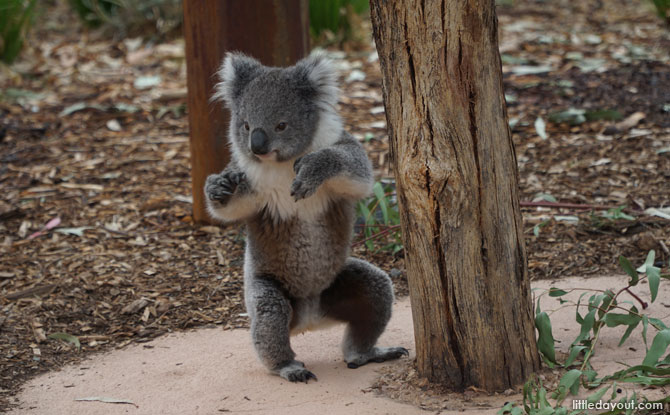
[{"xmin": 244, "ymin": 161, "xmax": 330, "ymax": 221}]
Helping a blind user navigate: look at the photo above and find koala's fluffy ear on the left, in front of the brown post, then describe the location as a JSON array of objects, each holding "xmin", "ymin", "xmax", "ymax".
[{"xmin": 217, "ymin": 52, "xmax": 263, "ymax": 105}]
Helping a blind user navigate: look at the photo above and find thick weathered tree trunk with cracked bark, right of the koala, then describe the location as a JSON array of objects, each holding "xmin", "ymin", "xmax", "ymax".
[{"xmin": 370, "ymin": 0, "xmax": 539, "ymax": 391}]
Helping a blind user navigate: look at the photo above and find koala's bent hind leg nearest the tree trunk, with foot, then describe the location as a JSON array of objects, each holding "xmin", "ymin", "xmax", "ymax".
[{"xmin": 321, "ymin": 258, "xmax": 409, "ymax": 369}]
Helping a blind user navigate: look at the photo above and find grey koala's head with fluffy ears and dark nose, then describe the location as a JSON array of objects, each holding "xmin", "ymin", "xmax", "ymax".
[{"xmin": 213, "ymin": 53, "xmax": 341, "ymax": 166}]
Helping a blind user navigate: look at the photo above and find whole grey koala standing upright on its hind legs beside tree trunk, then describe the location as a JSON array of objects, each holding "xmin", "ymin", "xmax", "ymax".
[{"xmin": 205, "ymin": 53, "xmax": 408, "ymax": 382}]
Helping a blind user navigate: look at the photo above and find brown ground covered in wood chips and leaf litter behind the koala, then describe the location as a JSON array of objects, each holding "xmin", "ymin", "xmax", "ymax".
[{"xmin": 0, "ymin": 0, "xmax": 670, "ymax": 410}]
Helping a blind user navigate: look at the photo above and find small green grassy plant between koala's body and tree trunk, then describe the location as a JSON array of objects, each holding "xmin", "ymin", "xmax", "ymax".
[{"xmin": 354, "ymin": 182, "xmax": 402, "ymax": 253}]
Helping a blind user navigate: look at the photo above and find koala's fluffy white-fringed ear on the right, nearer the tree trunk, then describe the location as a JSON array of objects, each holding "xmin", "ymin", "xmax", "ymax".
[{"xmin": 295, "ymin": 52, "xmax": 340, "ymax": 106}]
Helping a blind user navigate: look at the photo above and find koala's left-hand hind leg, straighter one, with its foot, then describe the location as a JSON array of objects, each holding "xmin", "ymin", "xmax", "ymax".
[{"xmin": 245, "ymin": 277, "xmax": 316, "ymax": 382}]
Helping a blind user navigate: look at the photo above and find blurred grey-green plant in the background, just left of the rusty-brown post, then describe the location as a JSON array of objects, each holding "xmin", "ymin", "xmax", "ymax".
[{"xmin": 69, "ymin": 0, "xmax": 182, "ymax": 35}]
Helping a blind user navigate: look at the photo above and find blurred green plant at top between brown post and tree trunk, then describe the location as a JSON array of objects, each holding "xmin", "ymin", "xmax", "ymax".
[{"xmin": 309, "ymin": 0, "xmax": 369, "ymax": 41}]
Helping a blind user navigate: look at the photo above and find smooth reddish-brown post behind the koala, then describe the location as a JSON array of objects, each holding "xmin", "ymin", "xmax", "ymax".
[{"xmin": 183, "ymin": 0, "xmax": 309, "ymax": 222}]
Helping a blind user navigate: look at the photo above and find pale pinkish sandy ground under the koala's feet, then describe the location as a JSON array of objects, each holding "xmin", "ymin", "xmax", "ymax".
[{"xmin": 11, "ymin": 277, "xmax": 670, "ymax": 415}]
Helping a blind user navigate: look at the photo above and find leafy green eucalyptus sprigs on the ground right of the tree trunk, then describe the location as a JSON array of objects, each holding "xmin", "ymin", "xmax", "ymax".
[{"xmin": 498, "ymin": 250, "xmax": 670, "ymax": 415}]
